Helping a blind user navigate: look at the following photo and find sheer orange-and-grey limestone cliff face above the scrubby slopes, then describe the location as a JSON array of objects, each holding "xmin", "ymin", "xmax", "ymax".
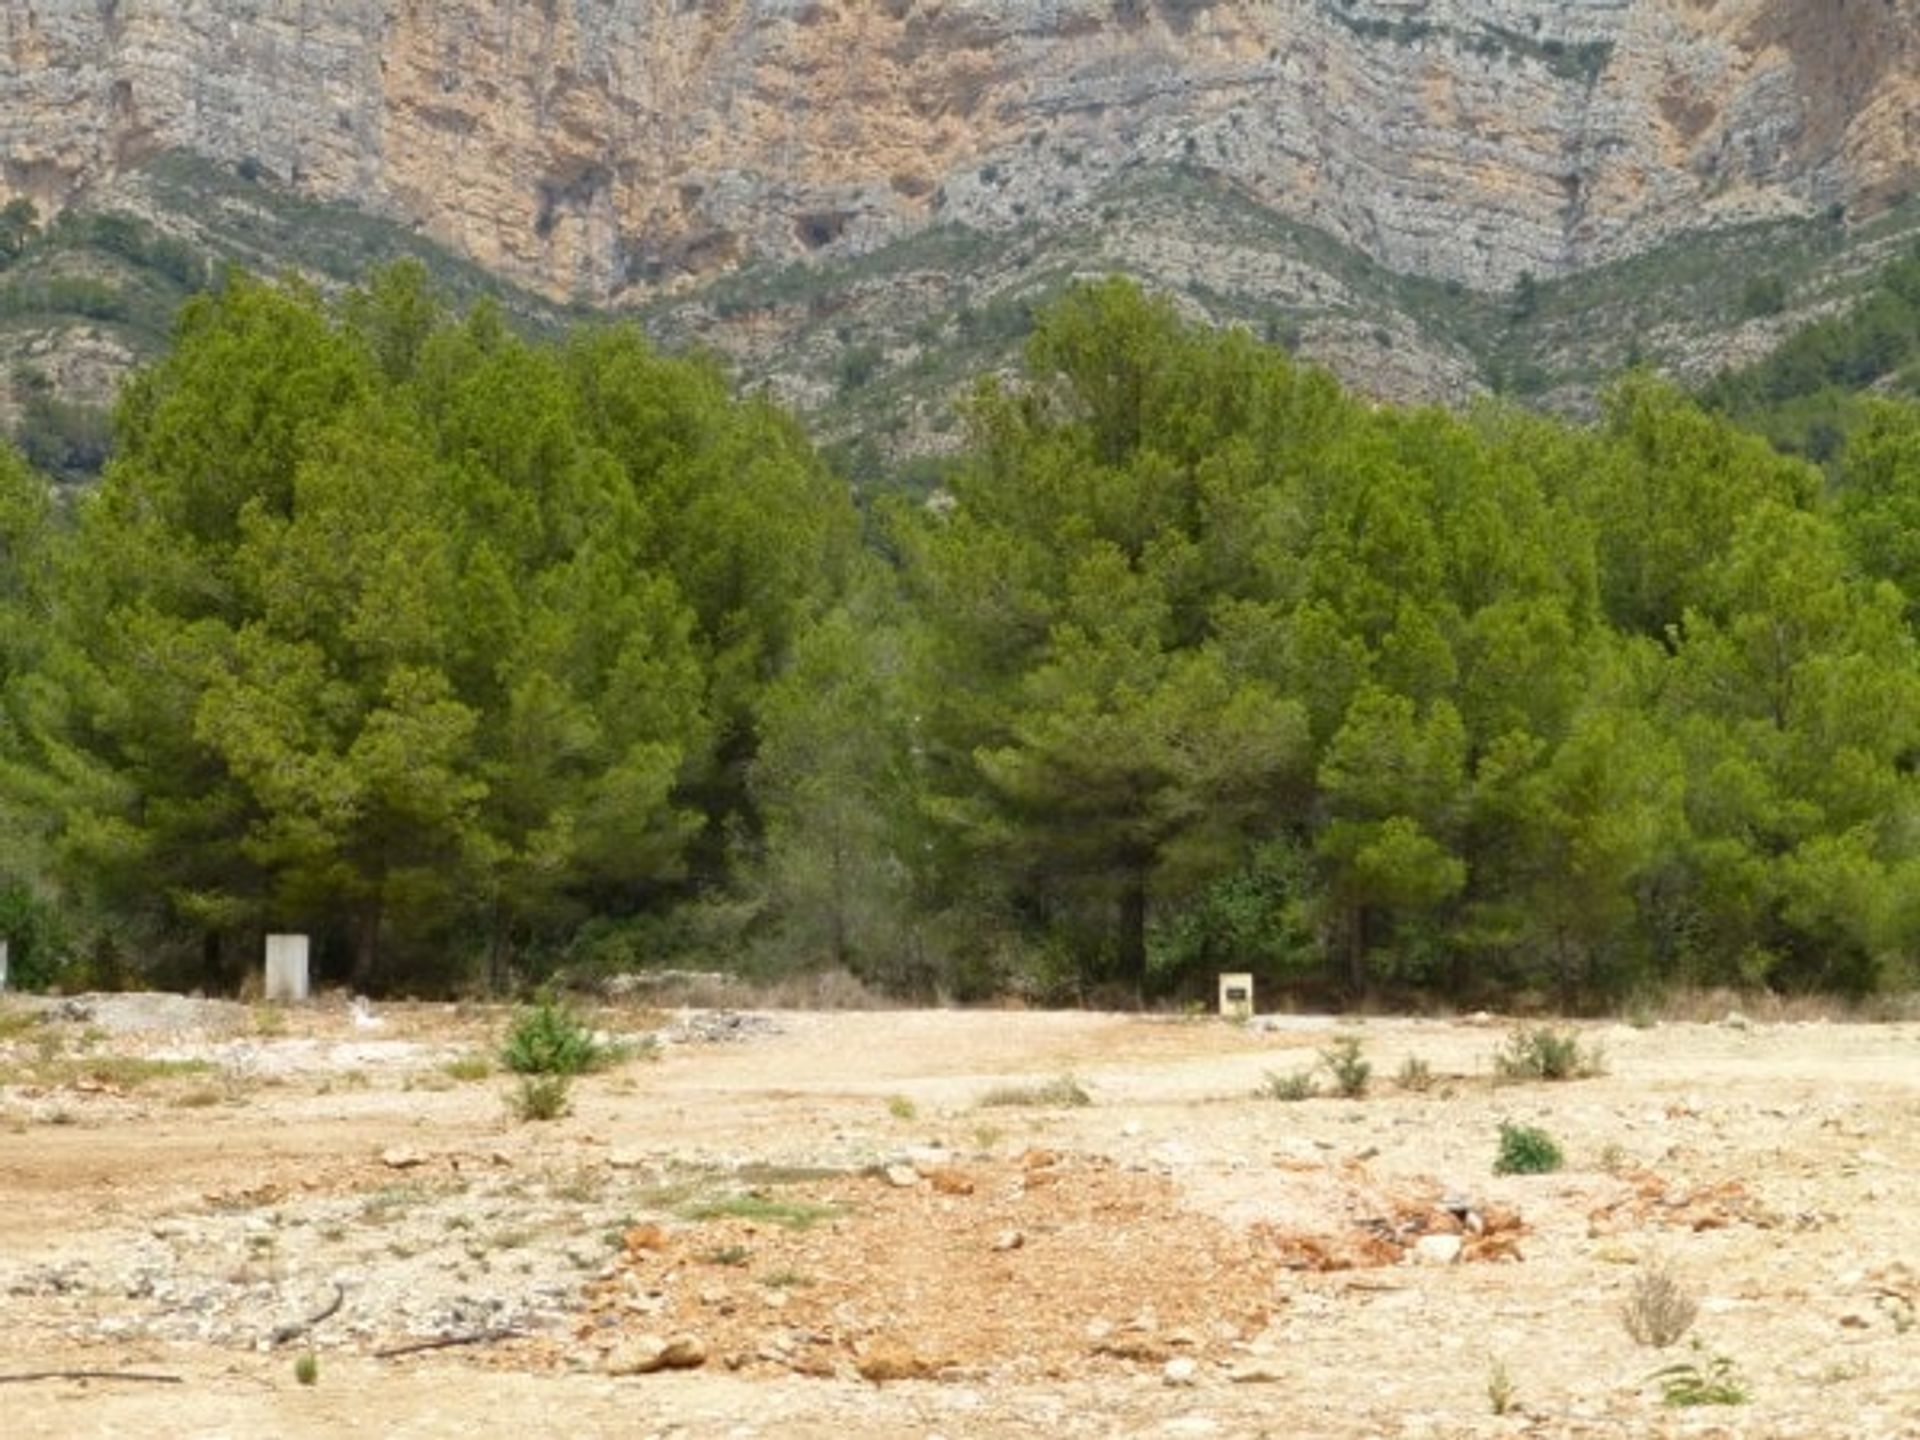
[{"xmin": 0, "ymin": 0, "xmax": 1920, "ymax": 303}]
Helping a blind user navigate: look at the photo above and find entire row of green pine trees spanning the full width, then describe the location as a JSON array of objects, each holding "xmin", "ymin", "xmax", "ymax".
[{"xmin": 0, "ymin": 269, "xmax": 1920, "ymax": 1004}]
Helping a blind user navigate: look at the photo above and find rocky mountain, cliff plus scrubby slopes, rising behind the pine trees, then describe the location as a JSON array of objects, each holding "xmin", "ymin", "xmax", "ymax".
[{"xmin": 0, "ymin": 0, "xmax": 1920, "ymax": 462}]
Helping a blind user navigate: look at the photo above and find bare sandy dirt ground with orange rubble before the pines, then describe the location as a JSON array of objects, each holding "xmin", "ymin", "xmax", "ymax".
[{"xmin": 0, "ymin": 996, "xmax": 1920, "ymax": 1440}]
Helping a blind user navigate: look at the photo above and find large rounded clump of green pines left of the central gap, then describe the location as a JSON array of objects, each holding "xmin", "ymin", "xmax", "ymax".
[{"xmin": 1, "ymin": 271, "xmax": 854, "ymax": 983}]
